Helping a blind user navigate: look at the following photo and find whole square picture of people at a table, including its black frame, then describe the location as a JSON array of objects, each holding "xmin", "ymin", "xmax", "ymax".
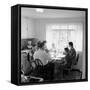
[{"xmin": 11, "ymin": 4, "xmax": 88, "ymax": 85}]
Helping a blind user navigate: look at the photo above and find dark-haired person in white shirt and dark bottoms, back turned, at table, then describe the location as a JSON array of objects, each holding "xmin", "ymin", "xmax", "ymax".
[{"xmin": 33, "ymin": 42, "xmax": 54, "ymax": 80}]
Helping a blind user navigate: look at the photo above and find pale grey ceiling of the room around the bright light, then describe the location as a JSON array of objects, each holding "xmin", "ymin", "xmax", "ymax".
[{"xmin": 21, "ymin": 8, "xmax": 85, "ymax": 19}]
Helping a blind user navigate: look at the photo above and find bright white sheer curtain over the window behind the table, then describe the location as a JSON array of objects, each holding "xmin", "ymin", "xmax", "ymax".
[{"xmin": 46, "ymin": 23, "xmax": 83, "ymax": 51}]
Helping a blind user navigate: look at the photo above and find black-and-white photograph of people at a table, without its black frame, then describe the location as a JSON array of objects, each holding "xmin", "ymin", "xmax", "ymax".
[{"xmin": 21, "ymin": 7, "xmax": 86, "ymax": 83}]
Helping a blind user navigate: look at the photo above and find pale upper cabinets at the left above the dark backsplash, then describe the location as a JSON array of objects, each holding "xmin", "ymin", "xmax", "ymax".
[{"xmin": 21, "ymin": 17, "xmax": 35, "ymax": 38}]
